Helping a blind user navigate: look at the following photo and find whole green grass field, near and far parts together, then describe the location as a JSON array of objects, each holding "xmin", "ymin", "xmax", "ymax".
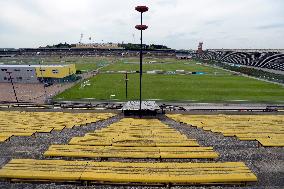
[{"xmin": 0, "ymin": 57, "xmax": 284, "ymax": 103}]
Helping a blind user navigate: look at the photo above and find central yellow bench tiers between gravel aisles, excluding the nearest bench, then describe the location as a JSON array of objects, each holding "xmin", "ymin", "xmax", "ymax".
[{"xmin": 45, "ymin": 118, "xmax": 218, "ymax": 158}]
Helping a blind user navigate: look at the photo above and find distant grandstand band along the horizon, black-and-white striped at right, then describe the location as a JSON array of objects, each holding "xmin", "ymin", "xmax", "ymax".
[{"xmin": 0, "ymin": 47, "xmax": 284, "ymax": 71}]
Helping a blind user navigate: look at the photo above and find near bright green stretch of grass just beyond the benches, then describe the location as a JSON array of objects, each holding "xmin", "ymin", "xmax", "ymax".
[{"xmin": 55, "ymin": 74, "xmax": 284, "ymax": 102}]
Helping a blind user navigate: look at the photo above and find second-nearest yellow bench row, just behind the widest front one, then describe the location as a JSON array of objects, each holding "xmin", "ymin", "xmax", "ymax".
[{"xmin": 44, "ymin": 145, "xmax": 219, "ymax": 159}]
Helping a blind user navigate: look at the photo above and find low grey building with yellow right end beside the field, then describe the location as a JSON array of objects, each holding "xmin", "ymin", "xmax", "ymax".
[{"xmin": 0, "ymin": 64, "xmax": 76, "ymax": 83}]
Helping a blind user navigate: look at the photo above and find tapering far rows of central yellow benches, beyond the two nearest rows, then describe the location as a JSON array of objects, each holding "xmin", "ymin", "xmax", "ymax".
[{"xmin": 69, "ymin": 118, "xmax": 199, "ymax": 147}]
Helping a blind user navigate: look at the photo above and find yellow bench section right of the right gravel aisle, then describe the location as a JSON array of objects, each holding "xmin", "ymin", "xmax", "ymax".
[{"xmin": 167, "ymin": 114, "xmax": 284, "ymax": 147}]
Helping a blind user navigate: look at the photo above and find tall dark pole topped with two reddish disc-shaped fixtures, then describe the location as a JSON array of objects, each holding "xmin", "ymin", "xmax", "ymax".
[{"xmin": 135, "ymin": 6, "xmax": 148, "ymax": 115}]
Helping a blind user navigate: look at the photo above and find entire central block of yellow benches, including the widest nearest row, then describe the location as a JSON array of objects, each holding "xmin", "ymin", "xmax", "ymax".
[{"xmin": 0, "ymin": 118, "xmax": 257, "ymax": 184}]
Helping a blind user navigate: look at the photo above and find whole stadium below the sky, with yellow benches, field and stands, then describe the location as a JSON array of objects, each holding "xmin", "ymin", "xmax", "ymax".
[{"xmin": 0, "ymin": 0, "xmax": 284, "ymax": 189}]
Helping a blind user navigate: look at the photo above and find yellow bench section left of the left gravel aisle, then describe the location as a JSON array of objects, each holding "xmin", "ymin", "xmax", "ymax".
[{"xmin": 0, "ymin": 111, "xmax": 114, "ymax": 142}]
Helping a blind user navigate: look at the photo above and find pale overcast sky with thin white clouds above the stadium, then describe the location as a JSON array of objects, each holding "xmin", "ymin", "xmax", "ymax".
[{"xmin": 0, "ymin": 0, "xmax": 284, "ymax": 49}]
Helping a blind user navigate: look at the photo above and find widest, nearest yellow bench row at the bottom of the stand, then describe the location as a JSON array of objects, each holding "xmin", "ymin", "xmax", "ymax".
[{"xmin": 0, "ymin": 159, "xmax": 257, "ymax": 184}]
